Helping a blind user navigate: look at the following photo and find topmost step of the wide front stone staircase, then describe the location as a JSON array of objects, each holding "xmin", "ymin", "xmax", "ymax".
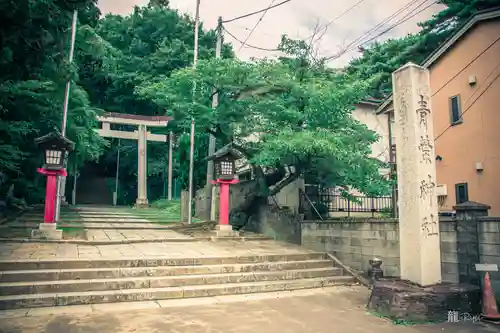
[{"xmin": 0, "ymin": 252, "xmax": 329, "ymax": 271}]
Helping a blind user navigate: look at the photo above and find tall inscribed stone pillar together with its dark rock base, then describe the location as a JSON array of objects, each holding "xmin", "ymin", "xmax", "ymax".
[{"xmin": 367, "ymin": 63, "xmax": 480, "ymax": 321}]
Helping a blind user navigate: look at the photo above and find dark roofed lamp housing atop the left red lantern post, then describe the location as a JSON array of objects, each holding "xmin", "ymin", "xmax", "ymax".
[{"xmin": 35, "ymin": 132, "xmax": 75, "ymax": 170}]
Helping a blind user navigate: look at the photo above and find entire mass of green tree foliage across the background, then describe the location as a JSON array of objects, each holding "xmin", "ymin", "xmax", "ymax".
[{"xmin": 0, "ymin": 0, "xmax": 500, "ymax": 209}]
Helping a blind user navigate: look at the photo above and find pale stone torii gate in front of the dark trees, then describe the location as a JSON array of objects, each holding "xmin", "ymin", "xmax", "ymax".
[{"xmin": 96, "ymin": 113, "xmax": 172, "ymax": 208}]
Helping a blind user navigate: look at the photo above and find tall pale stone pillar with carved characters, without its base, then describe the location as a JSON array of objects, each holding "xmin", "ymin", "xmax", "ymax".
[{"xmin": 392, "ymin": 63, "xmax": 441, "ymax": 286}]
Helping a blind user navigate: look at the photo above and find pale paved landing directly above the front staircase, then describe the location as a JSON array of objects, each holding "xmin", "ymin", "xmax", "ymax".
[{"xmin": 0, "ymin": 241, "xmax": 313, "ymax": 260}]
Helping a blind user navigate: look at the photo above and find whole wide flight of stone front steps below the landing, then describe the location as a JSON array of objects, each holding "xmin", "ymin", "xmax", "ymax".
[{"xmin": 0, "ymin": 252, "xmax": 355, "ymax": 310}]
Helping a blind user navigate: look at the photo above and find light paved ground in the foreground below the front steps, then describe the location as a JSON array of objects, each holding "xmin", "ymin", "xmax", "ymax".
[{"xmin": 0, "ymin": 287, "xmax": 492, "ymax": 333}]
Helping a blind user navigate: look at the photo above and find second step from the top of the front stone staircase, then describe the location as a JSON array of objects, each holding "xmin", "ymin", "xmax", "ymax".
[{"xmin": 0, "ymin": 260, "xmax": 332, "ymax": 283}]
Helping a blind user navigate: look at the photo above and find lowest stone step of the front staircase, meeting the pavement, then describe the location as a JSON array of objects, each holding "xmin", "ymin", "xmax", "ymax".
[{"xmin": 0, "ymin": 276, "xmax": 354, "ymax": 310}]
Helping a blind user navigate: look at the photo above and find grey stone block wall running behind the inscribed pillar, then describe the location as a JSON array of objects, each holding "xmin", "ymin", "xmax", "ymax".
[{"xmin": 301, "ymin": 217, "xmax": 500, "ymax": 297}]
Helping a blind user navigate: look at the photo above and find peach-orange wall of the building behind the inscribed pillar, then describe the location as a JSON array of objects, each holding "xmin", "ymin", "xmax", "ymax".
[{"xmin": 430, "ymin": 20, "xmax": 500, "ymax": 216}]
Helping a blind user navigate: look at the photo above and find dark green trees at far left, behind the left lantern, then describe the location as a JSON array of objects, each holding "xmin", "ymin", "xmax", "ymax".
[{"xmin": 0, "ymin": 0, "xmax": 103, "ymax": 202}]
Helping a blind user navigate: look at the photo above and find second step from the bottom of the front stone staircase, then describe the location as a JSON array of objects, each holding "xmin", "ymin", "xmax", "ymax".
[{"xmin": 0, "ymin": 267, "xmax": 342, "ymax": 296}]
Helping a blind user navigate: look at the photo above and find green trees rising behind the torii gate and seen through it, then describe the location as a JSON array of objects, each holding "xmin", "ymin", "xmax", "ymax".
[{"xmin": 80, "ymin": 1, "xmax": 233, "ymax": 202}]
